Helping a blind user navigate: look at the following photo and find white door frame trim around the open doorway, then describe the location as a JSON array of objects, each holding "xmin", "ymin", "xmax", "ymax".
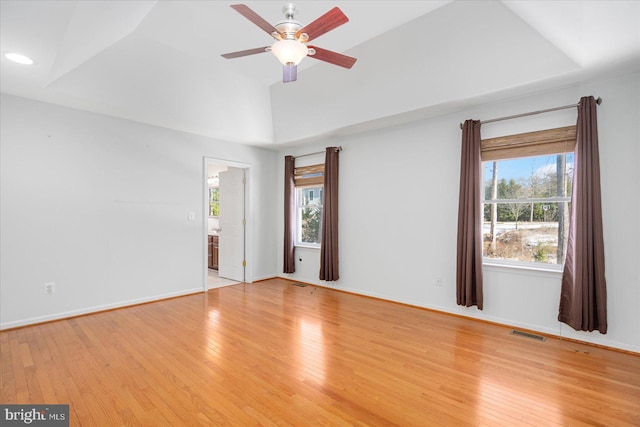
[{"xmin": 201, "ymin": 156, "xmax": 252, "ymax": 292}]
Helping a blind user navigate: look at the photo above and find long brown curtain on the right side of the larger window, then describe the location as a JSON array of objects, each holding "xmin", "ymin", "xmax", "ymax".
[{"xmin": 558, "ymin": 96, "xmax": 607, "ymax": 334}]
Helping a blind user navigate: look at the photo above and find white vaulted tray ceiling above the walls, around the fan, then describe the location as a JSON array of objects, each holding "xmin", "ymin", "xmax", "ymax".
[{"xmin": 0, "ymin": 0, "xmax": 640, "ymax": 148}]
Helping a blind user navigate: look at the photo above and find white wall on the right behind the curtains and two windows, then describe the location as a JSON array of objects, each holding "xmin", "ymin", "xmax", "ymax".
[{"xmin": 277, "ymin": 74, "xmax": 640, "ymax": 352}]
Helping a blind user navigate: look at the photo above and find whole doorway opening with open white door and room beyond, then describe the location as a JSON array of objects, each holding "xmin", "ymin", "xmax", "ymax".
[{"xmin": 203, "ymin": 158, "xmax": 249, "ymax": 291}]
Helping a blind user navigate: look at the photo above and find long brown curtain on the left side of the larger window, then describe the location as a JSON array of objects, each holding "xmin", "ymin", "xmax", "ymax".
[{"xmin": 456, "ymin": 120, "xmax": 482, "ymax": 310}]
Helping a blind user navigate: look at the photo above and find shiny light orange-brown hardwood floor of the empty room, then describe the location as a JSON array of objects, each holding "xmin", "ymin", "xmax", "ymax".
[{"xmin": 0, "ymin": 279, "xmax": 640, "ymax": 426}]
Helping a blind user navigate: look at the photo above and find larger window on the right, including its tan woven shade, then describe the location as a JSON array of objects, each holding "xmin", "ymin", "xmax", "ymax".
[{"xmin": 482, "ymin": 126, "xmax": 575, "ymax": 265}]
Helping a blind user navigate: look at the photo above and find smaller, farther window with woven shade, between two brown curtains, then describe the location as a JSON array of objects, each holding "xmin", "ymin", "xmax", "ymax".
[{"xmin": 294, "ymin": 164, "xmax": 324, "ymax": 247}]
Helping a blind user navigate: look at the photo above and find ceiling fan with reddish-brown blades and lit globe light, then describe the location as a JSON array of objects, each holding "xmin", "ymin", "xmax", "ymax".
[{"xmin": 222, "ymin": 3, "xmax": 356, "ymax": 83}]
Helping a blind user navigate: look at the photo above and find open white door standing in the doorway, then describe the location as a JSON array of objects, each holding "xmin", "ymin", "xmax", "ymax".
[{"xmin": 218, "ymin": 167, "xmax": 245, "ymax": 282}]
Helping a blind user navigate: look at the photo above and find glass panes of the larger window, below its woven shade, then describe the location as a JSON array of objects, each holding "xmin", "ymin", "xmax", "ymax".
[{"xmin": 483, "ymin": 153, "xmax": 574, "ymax": 264}]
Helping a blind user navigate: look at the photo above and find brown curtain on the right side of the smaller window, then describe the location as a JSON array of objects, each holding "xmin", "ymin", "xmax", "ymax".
[{"xmin": 320, "ymin": 147, "xmax": 340, "ymax": 281}]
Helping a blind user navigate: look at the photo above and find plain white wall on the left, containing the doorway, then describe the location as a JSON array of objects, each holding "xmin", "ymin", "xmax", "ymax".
[{"xmin": 0, "ymin": 94, "xmax": 277, "ymax": 328}]
